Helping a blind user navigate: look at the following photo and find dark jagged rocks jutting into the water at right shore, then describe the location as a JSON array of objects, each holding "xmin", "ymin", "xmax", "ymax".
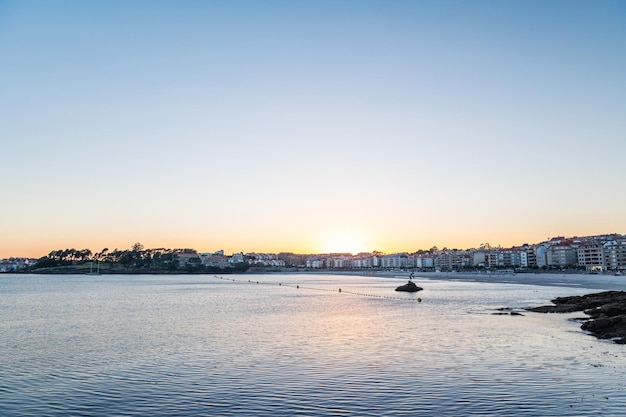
[{"xmin": 527, "ymin": 291, "xmax": 626, "ymax": 344}]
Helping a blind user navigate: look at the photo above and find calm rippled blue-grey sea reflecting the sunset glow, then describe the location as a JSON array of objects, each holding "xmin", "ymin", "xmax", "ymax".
[{"xmin": 0, "ymin": 275, "xmax": 626, "ymax": 416}]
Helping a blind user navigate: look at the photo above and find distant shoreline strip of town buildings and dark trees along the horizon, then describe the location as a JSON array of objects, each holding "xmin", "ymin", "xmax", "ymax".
[{"xmin": 0, "ymin": 234, "xmax": 626, "ymax": 275}]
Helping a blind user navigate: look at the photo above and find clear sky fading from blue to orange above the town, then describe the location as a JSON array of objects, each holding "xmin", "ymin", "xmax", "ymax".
[{"xmin": 0, "ymin": 0, "xmax": 626, "ymax": 258}]
